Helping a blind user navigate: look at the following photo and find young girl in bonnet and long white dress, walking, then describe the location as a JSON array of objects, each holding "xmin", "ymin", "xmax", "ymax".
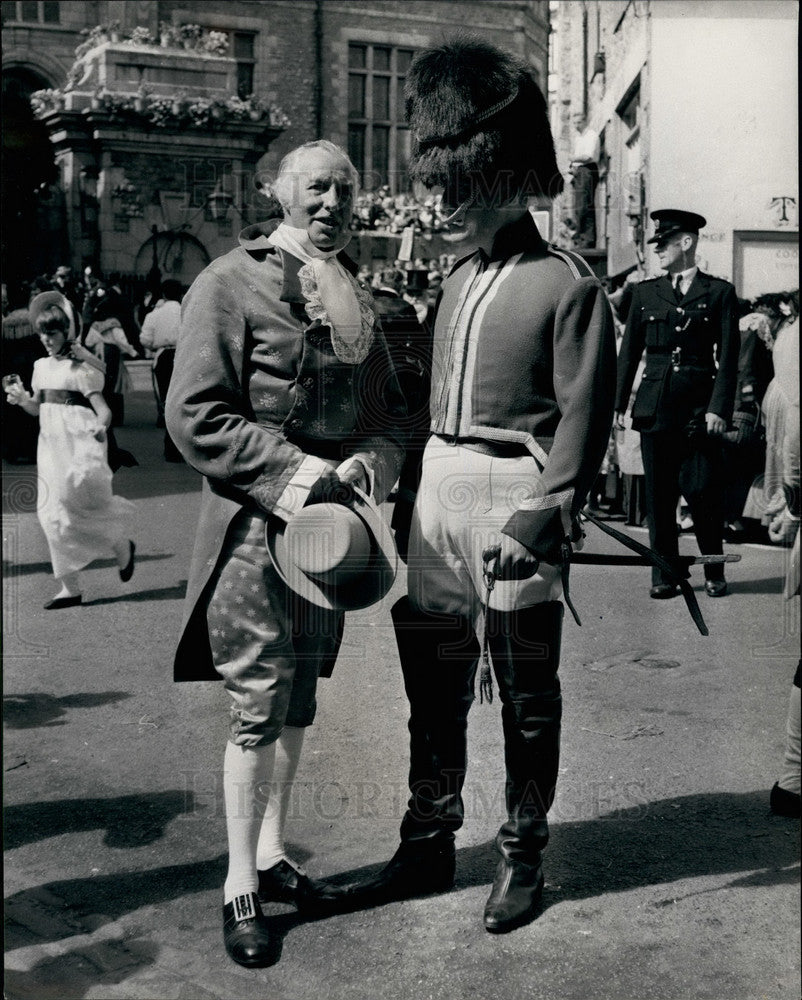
[{"xmin": 4, "ymin": 292, "xmax": 135, "ymax": 610}]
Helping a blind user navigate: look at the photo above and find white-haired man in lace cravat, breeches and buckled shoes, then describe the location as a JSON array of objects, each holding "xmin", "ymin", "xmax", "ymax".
[{"xmin": 166, "ymin": 140, "xmax": 406, "ymax": 966}]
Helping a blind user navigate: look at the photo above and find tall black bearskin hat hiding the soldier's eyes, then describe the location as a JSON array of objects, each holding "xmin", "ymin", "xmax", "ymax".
[{"xmin": 404, "ymin": 36, "xmax": 563, "ymax": 204}]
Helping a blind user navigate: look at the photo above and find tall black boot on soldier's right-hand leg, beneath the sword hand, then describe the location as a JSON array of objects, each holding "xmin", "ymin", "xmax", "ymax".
[{"xmin": 485, "ymin": 601, "xmax": 563, "ymax": 933}]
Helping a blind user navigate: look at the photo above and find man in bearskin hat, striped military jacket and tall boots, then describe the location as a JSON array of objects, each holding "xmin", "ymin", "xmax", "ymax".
[{"xmin": 361, "ymin": 39, "xmax": 615, "ymax": 932}]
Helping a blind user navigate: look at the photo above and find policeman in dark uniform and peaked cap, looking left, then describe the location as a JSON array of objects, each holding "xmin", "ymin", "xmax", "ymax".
[{"xmin": 616, "ymin": 209, "xmax": 740, "ymax": 598}]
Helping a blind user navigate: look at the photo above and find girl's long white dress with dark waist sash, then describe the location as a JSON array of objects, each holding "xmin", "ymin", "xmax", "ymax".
[{"xmin": 31, "ymin": 357, "xmax": 134, "ymax": 577}]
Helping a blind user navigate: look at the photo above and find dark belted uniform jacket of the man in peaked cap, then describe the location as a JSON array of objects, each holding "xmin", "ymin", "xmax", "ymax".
[{"xmin": 616, "ymin": 271, "xmax": 740, "ymax": 435}]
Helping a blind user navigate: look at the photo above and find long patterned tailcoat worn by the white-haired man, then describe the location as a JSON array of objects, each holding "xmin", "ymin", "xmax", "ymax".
[{"xmin": 165, "ymin": 220, "xmax": 406, "ymax": 681}]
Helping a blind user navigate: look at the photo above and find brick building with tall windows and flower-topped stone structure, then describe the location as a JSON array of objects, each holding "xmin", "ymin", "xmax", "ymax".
[{"xmin": 0, "ymin": 0, "xmax": 549, "ymax": 292}]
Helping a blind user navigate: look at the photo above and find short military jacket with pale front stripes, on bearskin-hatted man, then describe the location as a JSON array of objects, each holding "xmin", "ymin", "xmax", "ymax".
[{"xmin": 396, "ymin": 214, "xmax": 615, "ymax": 562}]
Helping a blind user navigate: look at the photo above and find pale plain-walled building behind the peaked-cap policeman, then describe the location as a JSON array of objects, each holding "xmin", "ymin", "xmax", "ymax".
[{"xmin": 551, "ymin": 0, "xmax": 799, "ymax": 297}]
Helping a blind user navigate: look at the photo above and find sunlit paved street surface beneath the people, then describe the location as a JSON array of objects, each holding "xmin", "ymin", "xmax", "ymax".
[{"xmin": 3, "ymin": 368, "xmax": 800, "ymax": 1000}]
